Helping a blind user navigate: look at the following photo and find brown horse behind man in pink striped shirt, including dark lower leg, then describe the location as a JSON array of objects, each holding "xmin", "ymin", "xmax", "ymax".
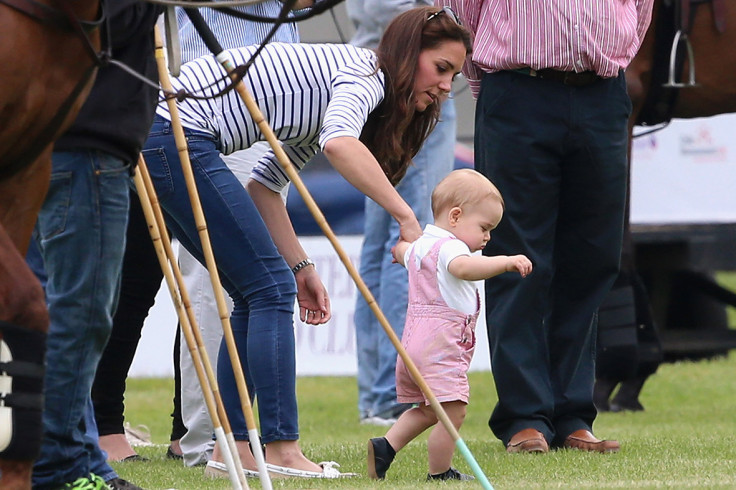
[{"xmin": 594, "ymin": 0, "xmax": 736, "ymax": 411}]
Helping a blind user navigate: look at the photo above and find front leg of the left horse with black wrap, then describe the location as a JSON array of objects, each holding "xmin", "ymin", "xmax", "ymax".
[{"xmin": 0, "ymin": 154, "xmax": 51, "ymax": 490}]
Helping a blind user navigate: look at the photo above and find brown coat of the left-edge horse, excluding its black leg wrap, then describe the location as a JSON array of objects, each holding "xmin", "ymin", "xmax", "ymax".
[{"xmin": 0, "ymin": 0, "xmax": 100, "ymax": 489}]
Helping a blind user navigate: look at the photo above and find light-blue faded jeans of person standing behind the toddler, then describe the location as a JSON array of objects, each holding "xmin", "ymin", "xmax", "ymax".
[{"xmin": 354, "ymin": 99, "xmax": 456, "ymax": 418}]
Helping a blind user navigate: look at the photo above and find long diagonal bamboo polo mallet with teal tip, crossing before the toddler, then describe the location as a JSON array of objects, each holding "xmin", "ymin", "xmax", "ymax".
[{"xmin": 186, "ymin": 9, "xmax": 493, "ymax": 490}]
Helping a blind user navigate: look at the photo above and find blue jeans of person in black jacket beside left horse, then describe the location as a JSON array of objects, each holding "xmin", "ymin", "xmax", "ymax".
[{"xmin": 33, "ymin": 152, "xmax": 130, "ymax": 488}]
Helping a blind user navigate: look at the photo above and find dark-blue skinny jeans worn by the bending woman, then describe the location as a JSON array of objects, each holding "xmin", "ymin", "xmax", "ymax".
[{"xmin": 143, "ymin": 116, "xmax": 299, "ymax": 444}]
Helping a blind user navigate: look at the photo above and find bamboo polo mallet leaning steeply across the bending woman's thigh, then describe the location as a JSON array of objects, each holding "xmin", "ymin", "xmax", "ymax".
[{"xmin": 155, "ymin": 29, "xmax": 272, "ymax": 490}]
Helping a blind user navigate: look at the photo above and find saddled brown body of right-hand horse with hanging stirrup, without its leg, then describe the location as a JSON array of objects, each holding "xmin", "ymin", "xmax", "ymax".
[{"xmin": 626, "ymin": 0, "xmax": 736, "ymax": 122}]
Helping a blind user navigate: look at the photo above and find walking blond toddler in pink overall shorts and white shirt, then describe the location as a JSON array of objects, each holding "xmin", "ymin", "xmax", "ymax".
[{"xmin": 368, "ymin": 169, "xmax": 532, "ymax": 480}]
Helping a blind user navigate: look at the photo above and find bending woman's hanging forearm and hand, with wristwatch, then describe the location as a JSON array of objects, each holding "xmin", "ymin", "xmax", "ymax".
[{"xmin": 246, "ymin": 179, "xmax": 332, "ymax": 325}]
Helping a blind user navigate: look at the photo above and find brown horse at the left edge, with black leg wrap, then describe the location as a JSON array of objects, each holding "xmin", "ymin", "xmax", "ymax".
[{"xmin": 0, "ymin": 0, "xmax": 104, "ymax": 489}]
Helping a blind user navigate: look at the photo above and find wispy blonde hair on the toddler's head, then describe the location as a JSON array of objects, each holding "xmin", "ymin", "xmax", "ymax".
[{"xmin": 432, "ymin": 168, "xmax": 506, "ymax": 219}]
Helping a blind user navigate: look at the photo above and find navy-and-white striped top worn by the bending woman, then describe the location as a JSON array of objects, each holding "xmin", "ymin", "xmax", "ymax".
[{"xmin": 157, "ymin": 43, "xmax": 384, "ymax": 192}]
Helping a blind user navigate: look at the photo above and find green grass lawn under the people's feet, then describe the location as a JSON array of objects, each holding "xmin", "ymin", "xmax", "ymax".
[{"xmin": 114, "ymin": 354, "xmax": 736, "ymax": 490}]
